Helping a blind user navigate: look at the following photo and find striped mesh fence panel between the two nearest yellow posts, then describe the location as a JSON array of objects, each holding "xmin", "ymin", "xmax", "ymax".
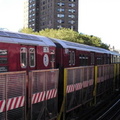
[{"xmin": 64, "ymin": 66, "xmax": 94, "ymax": 112}]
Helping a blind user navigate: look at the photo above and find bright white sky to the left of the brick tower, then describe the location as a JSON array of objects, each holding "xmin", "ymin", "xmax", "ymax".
[{"xmin": 0, "ymin": 0, "xmax": 24, "ymax": 32}]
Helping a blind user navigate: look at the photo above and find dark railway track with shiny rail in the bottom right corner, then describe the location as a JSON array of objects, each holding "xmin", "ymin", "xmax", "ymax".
[{"xmin": 76, "ymin": 91, "xmax": 120, "ymax": 120}]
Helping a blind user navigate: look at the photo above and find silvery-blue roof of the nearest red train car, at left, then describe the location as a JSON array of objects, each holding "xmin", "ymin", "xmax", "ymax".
[{"xmin": 0, "ymin": 31, "xmax": 56, "ymax": 46}]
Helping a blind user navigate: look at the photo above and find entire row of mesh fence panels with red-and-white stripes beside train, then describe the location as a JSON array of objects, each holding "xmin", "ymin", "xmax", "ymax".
[{"xmin": 0, "ymin": 64, "xmax": 120, "ymax": 120}]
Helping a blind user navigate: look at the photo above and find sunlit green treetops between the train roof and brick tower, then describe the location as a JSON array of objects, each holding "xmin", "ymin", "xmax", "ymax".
[{"xmin": 20, "ymin": 28, "xmax": 109, "ymax": 49}]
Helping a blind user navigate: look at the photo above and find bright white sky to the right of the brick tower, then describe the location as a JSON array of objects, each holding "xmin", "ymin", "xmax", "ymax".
[{"xmin": 79, "ymin": 0, "xmax": 120, "ymax": 50}]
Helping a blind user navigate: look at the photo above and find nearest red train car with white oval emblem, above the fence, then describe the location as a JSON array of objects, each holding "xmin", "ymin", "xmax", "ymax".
[{"xmin": 0, "ymin": 31, "xmax": 56, "ymax": 72}]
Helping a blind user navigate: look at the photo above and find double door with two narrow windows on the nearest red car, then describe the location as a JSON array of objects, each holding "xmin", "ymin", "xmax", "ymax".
[{"xmin": 20, "ymin": 46, "xmax": 36, "ymax": 71}]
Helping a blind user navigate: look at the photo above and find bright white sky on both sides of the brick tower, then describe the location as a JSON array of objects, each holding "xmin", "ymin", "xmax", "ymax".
[{"xmin": 0, "ymin": 0, "xmax": 120, "ymax": 50}]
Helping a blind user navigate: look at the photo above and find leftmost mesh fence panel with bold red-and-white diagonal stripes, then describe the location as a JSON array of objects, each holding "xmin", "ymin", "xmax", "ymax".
[{"xmin": 0, "ymin": 72, "xmax": 26, "ymax": 120}]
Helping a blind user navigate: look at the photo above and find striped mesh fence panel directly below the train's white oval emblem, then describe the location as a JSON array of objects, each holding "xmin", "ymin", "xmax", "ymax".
[{"xmin": 29, "ymin": 69, "xmax": 59, "ymax": 120}]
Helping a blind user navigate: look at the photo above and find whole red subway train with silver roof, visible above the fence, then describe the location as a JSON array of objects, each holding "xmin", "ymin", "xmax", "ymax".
[{"xmin": 0, "ymin": 31, "xmax": 120, "ymax": 72}]
